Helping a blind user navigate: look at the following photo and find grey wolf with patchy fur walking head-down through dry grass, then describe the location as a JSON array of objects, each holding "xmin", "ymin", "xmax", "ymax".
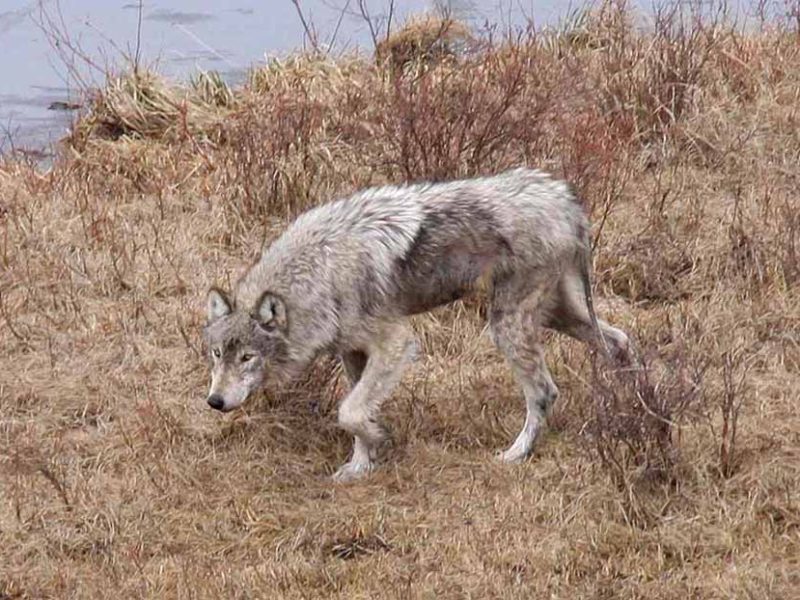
[{"xmin": 204, "ymin": 168, "xmax": 629, "ymax": 481}]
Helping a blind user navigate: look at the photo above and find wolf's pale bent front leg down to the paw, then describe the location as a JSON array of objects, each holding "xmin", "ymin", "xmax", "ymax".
[{"xmin": 333, "ymin": 323, "xmax": 417, "ymax": 482}]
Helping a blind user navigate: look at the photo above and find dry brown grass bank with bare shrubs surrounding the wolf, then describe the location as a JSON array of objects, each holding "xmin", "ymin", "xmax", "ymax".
[{"xmin": 0, "ymin": 5, "xmax": 800, "ymax": 600}]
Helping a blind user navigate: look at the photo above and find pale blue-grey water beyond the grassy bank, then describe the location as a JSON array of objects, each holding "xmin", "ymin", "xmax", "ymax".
[{"xmin": 0, "ymin": 0, "xmax": 768, "ymax": 152}]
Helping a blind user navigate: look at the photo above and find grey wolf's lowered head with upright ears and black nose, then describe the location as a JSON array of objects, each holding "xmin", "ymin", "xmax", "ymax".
[{"xmin": 203, "ymin": 288, "xmax": 289, "ymax": 412}]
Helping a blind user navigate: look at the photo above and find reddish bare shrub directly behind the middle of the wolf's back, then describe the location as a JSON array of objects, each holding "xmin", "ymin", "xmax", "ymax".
[{"xmin": 356, "ymin": 37, "xmax": 558, "ymax": 181}]
